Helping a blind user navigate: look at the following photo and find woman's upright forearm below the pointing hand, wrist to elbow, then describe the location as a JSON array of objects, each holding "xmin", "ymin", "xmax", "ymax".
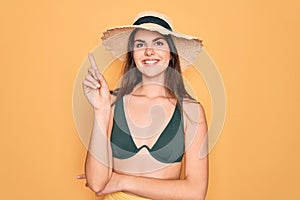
[{"xmin": 85, "ymin": 111, "xmax": 112, "ymax": 192}]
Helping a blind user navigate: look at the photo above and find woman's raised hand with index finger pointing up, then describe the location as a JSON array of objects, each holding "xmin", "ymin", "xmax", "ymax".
[{"xmin": 82, "ymin": 53, "xmax": 111, "ymax": 110}]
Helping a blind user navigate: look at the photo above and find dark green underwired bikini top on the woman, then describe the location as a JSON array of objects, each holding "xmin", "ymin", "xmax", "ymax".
[{"xmin": 110, "ymin": 98, "xmax": 185, "ymax": 163}]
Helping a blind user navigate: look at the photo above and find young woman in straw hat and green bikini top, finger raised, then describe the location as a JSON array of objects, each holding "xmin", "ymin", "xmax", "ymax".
[{"xmin": 78, "ymin": 12, "xmax": 208, "ymax": 200}]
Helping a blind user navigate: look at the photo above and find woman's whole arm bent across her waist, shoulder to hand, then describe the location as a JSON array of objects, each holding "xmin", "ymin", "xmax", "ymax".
[{"xmin": 98, "ymin": 103, "xmax": 208, "ymax": 200}]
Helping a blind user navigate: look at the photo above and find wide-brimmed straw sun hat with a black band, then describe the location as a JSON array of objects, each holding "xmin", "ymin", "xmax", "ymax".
[{"xmin": 101, "ymin": 11, "xmax": 202, "ymax": 70}]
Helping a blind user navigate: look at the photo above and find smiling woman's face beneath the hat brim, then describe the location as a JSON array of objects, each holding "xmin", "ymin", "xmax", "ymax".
[{"xmin": 133, "ymin": 30, "xmax": 171, "ymax": 77}]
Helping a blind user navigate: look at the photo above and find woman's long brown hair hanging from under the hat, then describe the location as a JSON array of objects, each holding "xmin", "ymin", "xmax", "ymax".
[{"xmin": 113, "ymin": 28, "xmax": 196, "ymax": 102}]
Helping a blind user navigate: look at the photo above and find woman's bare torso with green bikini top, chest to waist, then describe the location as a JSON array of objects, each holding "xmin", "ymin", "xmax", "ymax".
[{"xmin": 110, "ymin": 94, "xmax": 184, "ymax": 179}]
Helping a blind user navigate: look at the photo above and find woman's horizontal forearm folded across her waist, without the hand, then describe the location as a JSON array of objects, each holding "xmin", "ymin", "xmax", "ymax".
[{"xmin": 121, "ymin": 175, "xmax": 207, "ymax": 200}]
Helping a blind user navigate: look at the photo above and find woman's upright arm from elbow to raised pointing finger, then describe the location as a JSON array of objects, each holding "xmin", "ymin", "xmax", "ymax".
[{"xmin": 83, "ymin": 54, "xmax": 112, "ymax": 192}]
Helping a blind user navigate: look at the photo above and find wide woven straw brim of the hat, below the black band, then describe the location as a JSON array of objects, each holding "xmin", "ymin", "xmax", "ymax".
[{"xmin": 101, "ymin": 23, "xmax": 202, "ymax": 70}]
